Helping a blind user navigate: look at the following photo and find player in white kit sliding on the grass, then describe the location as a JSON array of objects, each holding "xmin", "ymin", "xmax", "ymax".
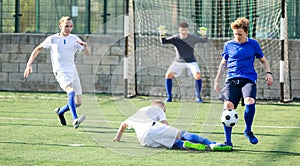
[{"xmin": 113, "ymin": 100, "xmax": 232, "ymax": 151}]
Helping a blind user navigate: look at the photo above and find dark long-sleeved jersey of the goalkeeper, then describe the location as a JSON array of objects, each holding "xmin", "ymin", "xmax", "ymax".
[{"xmin": 161, "ymin": 34, "xmax": 207, "ymax": 62}]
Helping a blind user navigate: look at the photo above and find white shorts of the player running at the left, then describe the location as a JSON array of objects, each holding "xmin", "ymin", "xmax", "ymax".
[{"xmin": 54, "ymin": 70, "xmax": 82, "ymax": 95}]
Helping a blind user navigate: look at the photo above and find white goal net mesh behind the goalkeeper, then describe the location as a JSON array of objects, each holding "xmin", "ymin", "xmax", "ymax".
[{"xmin": 127, "ymin": 0, "xmax": 289, "ymax": 99}]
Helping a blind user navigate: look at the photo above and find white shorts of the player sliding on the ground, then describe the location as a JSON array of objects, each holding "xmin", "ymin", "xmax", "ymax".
[{"xmin": 141, "ymin": 122, "xmax": 179, "ymax": 148}]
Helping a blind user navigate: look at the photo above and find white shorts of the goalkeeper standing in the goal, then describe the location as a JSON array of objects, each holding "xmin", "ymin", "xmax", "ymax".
[{"xmin": 168, "ymin": 61, "xmax": 200, "ymax": 77}]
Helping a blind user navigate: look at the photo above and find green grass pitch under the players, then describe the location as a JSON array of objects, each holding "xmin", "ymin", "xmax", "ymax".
[{"xmin": 0, "ymin": 92, "xmax": 300, "ymax": 165}]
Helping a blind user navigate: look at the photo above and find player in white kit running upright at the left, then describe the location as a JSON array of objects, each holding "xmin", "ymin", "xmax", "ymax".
[{"xmin": 24, "ymin": 16, "xmax": 90, "ymax": 129}]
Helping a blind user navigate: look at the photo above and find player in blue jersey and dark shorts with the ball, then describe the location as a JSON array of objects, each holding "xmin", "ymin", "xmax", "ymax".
[{"xmin": 214, "ymin": 17, "xmax": 273, "ymax": 146}]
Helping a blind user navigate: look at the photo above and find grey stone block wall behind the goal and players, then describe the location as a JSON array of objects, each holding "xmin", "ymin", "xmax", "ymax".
[{"xmin": 0, "ymin": 33, "xmax": 300, "ymax": 99}]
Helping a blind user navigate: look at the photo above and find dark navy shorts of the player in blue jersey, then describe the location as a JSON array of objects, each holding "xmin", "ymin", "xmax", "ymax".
[{"xmin": 219, "ymin": 78, "xmax": 256, "ymax": 109}]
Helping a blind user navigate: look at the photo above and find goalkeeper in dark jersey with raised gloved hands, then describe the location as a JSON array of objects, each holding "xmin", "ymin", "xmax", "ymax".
[{"xmin": 159, "ymin": 22, "xmax": 207, "ymax": 103}]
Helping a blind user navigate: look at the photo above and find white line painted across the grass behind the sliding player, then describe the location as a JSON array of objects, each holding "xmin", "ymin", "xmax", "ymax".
[{"xmin": 0, "ymin": 117, "xmax": 300, "ymax": 129}]
